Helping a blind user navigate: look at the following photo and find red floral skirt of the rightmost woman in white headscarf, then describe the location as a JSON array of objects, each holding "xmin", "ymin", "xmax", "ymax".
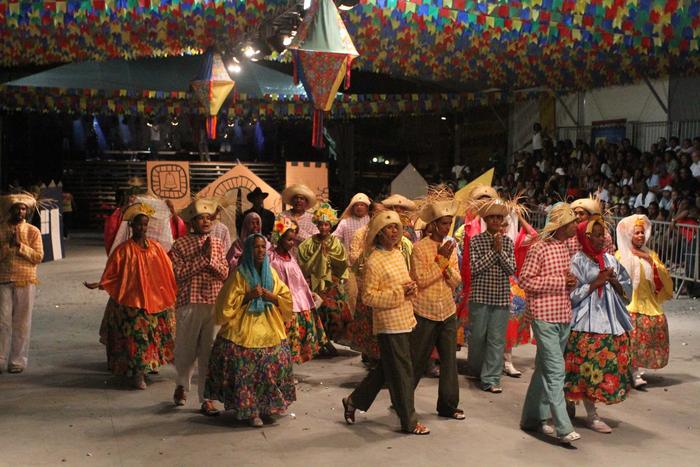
[{"xmin": 630, "ymin": 313, "xmax": 669, "ymax": 370}]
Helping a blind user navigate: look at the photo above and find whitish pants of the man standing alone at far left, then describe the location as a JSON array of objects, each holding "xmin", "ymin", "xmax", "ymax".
[{"xmin": 0, "ymin": 284, "xmax": 36, "ymax": 369}]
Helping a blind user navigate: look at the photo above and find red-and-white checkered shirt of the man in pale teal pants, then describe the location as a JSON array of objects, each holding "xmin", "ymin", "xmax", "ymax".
[{"xmin": 519, "ymin": 238, "xmax": 571, "ymax": 323}]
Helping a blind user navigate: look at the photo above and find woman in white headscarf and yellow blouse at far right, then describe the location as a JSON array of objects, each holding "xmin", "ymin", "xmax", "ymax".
[{"xmin": 615, "ymin": 215, "xmax": 673, "ymax": 388}]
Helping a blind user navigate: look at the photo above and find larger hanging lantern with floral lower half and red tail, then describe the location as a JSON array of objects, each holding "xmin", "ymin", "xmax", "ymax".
[{"xmin": 289, "ymin": 0, "xmax": 359, "ymax": 148}]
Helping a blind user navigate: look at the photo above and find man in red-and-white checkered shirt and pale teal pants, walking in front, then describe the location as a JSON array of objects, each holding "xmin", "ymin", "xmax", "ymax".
[{"xmin": 520, "ymin": 203, "xmax": 581, "ymax": 443}]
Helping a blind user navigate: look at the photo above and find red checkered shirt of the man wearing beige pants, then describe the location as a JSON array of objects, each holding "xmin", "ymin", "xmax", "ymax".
[{"xmin": 168, "ymin": 234, "xmax": 228, "ymax": 308}]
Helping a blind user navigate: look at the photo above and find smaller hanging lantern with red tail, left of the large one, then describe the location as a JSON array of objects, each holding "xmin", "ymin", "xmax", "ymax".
[{"xmin": 192, "ymin": 50, "xmax": 236, "ymax": 139}]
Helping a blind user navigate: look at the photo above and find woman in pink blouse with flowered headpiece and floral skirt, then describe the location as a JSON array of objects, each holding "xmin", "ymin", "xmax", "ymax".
[{"xmin": 269, "ymin": 216, "xmax": 328, "ymax": 364}]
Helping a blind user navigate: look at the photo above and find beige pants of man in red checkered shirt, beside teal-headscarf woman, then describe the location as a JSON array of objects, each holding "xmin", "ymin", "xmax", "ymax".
[{"xmin": 175, "ymin": 303, "xmax": 219, "ymax": 403}]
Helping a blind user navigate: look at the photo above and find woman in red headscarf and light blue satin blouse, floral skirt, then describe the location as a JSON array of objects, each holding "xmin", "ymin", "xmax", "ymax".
[{"xmin": 564, "ymin": 216, "xmax": 632, "ymax": 433}]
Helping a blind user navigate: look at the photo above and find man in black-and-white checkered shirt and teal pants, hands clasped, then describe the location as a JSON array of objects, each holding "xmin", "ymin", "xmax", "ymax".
[{"xmin": 467, "ymin": 198, "xmax": 515, "ymax": 393}]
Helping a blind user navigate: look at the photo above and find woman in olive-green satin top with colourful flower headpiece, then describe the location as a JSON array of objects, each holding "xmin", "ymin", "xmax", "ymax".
[{"xmin": 297, "ymin": 203, "xmax": 352, "ymax": 355}]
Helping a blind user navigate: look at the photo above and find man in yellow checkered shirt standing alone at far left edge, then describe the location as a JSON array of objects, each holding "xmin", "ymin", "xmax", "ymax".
[{"xmin": 0, "ymin": 194, "xmax": 44, "ymax": 373}]
